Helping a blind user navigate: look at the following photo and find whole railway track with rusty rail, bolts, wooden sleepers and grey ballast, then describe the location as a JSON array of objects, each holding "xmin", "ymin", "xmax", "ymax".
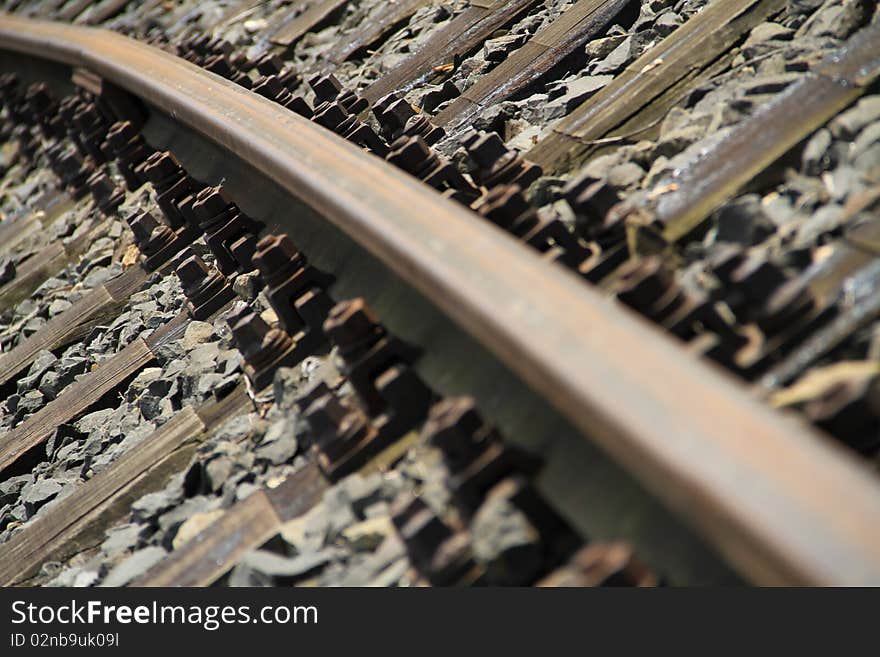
[{"xmin": 0, "ymin": 0, "xmax": 880, "ymax": 586}]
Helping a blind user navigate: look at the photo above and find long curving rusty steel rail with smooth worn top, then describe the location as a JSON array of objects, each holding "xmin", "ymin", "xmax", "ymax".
[{"xmin": 0, "ymin": 16, "xmax": 880, "ymax": 585}]
